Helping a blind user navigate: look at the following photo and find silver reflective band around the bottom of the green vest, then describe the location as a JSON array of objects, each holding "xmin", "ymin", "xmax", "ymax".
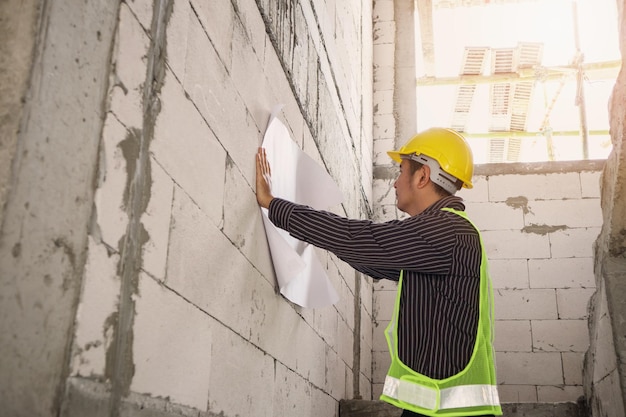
[{"xmin": 383, "ymin": 375, "xmax": 500, "ymax": 411}]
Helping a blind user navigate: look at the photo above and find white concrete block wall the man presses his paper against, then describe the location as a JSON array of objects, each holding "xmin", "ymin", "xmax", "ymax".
[{"xmin": 69, "ymin": 1, "xmax": 371, "ymax": 416}]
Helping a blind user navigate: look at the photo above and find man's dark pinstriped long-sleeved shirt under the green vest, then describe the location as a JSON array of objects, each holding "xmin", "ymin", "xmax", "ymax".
[{"xmin": 269, "ymin": 196, "xmax": 481, "ymax": 379}]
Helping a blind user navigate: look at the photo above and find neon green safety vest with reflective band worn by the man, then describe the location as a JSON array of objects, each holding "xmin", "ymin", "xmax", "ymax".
[{"xmin": 380, "ymin": 208, "xmax": 502, "ymax": 417}]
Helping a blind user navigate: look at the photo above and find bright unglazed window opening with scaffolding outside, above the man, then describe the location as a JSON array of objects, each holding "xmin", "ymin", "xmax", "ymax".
[{"xmin": 415, "ymin": 0, "xmax": 621, "ymax": 164}]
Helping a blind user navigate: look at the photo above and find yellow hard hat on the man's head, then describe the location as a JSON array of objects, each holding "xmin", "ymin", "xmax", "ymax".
[{"xmin": 387, "ymin": 127, "xmax": 474, "ymax": 188}]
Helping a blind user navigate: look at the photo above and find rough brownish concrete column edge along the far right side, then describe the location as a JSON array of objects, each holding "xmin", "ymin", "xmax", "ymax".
[{"xmin": 585, "ymin": 0, "xmax": 626, "ymax": 417}]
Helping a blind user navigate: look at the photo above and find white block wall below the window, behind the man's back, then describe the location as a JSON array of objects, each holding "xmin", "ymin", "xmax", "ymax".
[{"xmin": 373, "ymin": 162, "xmax": 602, "ymax": 403}]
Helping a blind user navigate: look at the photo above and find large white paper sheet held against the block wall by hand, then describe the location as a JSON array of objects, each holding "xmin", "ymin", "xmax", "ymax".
[{"xmin": 261, "ymin": 107, "xmax": 343, "ymax": 308}]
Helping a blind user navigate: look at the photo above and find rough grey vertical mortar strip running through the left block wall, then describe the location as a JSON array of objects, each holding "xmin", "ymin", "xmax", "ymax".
[{"xmin": 105, "ymin": 0, "xmax": 173, "ymax": 417}]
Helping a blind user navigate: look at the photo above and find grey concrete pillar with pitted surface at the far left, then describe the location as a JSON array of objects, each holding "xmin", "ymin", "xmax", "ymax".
[{"xmin": 0, "ymin": 1, "xmax": 118, "ymax": 416}]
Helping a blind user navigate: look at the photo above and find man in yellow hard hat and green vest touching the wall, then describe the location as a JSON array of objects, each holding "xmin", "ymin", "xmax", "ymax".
[{"xmin": 256, "ymin": 128, "xmax": 502, "ymax": 417}]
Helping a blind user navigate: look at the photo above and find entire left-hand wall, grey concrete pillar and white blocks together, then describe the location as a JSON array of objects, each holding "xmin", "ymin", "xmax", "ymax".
[{"xmin": 0, "ymin": 0, "xmax": 372, "ymax": 416}]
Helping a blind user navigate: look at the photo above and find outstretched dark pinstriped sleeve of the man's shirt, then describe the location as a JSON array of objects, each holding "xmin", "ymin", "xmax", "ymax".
[{"xmin": 269, "ymin": 198, "xmax": 455, "ymax": 279}]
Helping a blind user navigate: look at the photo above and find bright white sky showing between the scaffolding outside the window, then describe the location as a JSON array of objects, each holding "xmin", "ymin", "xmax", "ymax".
[{"xmin": 417, "ymin": 0, "xmax": 620, "ymax": 163}]
